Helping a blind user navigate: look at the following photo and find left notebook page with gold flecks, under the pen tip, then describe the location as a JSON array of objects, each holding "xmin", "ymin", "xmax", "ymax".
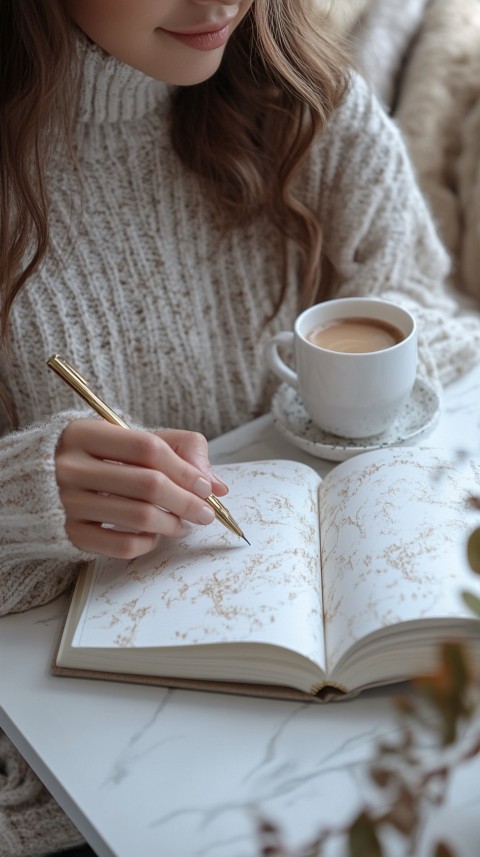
[{"xmin": 73, "ymin": 461, "xmax": 325, "ymax": 667}]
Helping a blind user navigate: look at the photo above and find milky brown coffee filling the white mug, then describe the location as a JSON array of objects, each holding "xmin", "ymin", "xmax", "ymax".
[{"xmin": 306, "ymin": 316, "xmax": 405, "ymax": 354}]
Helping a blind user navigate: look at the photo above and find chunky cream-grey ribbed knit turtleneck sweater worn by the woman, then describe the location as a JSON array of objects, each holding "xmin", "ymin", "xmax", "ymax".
[{"xmin": 0, "ymin": 36, "xmax": 480, "ymax": 857}]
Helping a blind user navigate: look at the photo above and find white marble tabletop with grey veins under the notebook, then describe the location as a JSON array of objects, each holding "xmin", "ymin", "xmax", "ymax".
[{"xmin": 0, "ymin": 367, "xmax": 480, "ymax": 857}]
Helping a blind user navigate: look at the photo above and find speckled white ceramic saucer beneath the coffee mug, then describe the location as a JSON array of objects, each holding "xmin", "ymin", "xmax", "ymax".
[{"xmin": 272, "ymin": 378, "xmax": 440, "ymax": 461}]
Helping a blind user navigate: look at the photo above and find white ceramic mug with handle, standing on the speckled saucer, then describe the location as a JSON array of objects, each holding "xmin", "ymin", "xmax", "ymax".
[{"xmin": 265, "ymin": 298, "xmax": 417, "ymax": 438}]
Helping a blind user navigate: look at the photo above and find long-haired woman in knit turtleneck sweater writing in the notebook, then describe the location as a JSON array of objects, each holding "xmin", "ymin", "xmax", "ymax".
[{"xmin": 0, "ymin": 0, "xmax": 479, "ymax": 857}]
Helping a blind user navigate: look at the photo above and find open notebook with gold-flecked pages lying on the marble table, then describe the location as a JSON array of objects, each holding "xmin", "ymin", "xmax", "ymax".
[{"xmin": 54, "ymin": 448, "xmax": 480, "ymax": 698}]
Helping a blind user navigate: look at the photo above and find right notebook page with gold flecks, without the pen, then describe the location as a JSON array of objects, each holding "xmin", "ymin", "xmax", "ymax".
[{"xmin": 320, "ymin": 448, "xmax": 480, "ymax": 672}]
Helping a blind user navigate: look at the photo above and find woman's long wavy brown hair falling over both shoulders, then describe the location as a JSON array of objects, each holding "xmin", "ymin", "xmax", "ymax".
[{"xmin": 0, "ymin": 0, "xmax": 348, "ymax": 350}]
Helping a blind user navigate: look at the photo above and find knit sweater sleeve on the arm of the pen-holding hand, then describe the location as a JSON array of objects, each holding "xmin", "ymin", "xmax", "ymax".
[{"xmin": 0, "ymin": 411, "xmax": 95, "ymax": 615}]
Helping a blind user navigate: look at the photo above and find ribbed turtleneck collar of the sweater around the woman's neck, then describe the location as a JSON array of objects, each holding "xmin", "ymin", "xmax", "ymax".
[{"xmin": 77, "ymin": 33, "xmax": 174, "ymax": 123}]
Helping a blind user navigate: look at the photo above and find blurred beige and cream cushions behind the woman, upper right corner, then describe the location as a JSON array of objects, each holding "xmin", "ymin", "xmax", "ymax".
[{"xmin": 311, "ymin": 0, "xmax": 480, "ymax": 302}]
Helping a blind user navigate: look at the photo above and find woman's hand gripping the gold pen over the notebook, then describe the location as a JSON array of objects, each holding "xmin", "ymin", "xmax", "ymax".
[{"xmin": 55, "ymin": 419, "xmax": 228, "ymax": 559}]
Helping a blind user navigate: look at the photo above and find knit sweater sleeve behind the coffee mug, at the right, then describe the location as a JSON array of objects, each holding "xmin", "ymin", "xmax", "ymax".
[{"xmin": 310, "ymin": 76, "xmax": 480, "ymax": 384}]
